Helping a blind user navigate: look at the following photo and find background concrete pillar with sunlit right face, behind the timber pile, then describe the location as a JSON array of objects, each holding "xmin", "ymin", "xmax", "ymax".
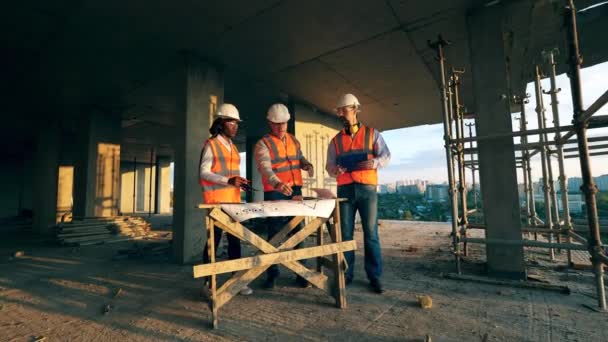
[{"xmin": 74, "ymin": 110, "xmax": 121, "ymax": 217}]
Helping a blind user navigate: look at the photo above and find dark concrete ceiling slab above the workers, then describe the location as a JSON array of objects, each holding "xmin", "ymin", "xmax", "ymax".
[{"xmin": 0, "ymin": 0, "xmax": 608, "ymax": 143}]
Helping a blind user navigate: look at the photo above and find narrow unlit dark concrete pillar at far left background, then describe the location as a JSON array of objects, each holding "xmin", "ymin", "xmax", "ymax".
[{"xmin": 32, "ymin": 124, "xmax": 59, "ymax": 235}]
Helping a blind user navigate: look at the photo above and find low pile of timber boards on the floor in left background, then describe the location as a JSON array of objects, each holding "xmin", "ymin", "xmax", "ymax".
[{"xmin": 55, "ymin": 216, "xmax": 150, "ymax": 246}]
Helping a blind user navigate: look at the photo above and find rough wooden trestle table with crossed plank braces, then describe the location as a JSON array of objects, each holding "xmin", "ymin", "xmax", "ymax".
[{"xmin": 193, "ymin": 199, "xmax": 357, "ymax": 328}]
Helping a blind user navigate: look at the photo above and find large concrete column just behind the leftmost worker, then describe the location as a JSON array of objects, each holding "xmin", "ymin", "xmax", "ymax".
[{"xmin": 173, "ymin": 56, "xmax": 224, "ymax": 264}]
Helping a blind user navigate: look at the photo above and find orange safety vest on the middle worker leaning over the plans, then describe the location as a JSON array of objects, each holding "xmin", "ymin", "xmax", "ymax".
[{"xmin": 262, "ymin": 133, "xmax": 302, "ymax": 191}]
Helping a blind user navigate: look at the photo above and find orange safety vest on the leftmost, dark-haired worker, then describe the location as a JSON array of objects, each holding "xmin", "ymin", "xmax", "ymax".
[{"xmin": 200, "ymin": 137, "xmax": 241, "ymax": 204}]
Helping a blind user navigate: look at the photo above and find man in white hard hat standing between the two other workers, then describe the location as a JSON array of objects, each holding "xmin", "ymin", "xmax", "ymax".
[{"xmin": 255, "ymin": 103, "xmax": 314, "ymax": 289}]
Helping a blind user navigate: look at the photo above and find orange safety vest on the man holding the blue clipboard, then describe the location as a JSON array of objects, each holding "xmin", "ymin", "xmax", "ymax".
[{"xmin": 332, "ymin": 125, "xmax": 378, "ymax": 186}]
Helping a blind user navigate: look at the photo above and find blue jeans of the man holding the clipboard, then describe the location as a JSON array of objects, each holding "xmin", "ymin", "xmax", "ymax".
[{"xmin": 338, "ymin": 183, "xmax": 382, "ymax": 280}]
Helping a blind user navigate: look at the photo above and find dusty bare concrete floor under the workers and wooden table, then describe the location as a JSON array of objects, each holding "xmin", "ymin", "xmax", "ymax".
[{"xmin": 0, "ymin": 221, "xmax": 608, "ymax": 341}]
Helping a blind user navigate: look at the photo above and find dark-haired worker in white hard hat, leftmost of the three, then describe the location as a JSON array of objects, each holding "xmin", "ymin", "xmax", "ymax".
[{"xmin": 199, "ymin": 103, "xmax": 253, "ymax": 295}]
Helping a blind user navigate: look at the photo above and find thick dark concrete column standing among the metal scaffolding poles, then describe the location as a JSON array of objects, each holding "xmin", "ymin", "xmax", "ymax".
[{"xmin": 468, "ymin": 3, "xmax": 526, "ymax": 279}]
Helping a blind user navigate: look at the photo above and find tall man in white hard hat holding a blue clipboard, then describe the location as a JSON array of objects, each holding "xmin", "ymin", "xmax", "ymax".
[{"xmin": 326, "ymin": 94, "xmax": 391, "ymax": 293}]
